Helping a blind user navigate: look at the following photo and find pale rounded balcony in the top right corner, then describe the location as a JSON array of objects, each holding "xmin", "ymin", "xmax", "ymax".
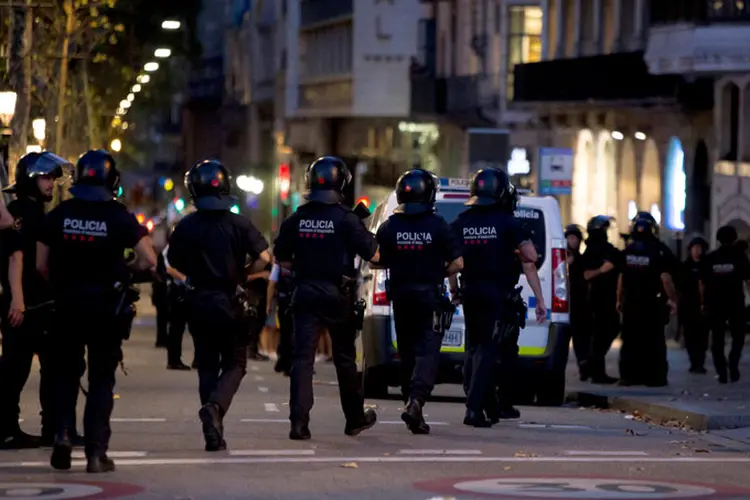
[{"xmin": 645, "ymin": 0, "xmax": 750, "ymax": 75}]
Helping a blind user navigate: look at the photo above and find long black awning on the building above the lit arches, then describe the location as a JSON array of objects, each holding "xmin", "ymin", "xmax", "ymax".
[{"xmin": 514, "ymin": 51, "xmax": 713, "ymax": 109}]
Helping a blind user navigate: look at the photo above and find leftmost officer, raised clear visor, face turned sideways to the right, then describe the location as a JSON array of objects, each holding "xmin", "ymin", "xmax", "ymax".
[{"xmin": 0, "ymin": 152, "xmax": 68, "ymax": 449}]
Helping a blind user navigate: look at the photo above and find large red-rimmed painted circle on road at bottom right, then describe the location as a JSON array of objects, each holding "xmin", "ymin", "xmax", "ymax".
[{"xmin": 415, "ymin": 477, "xmax": 750, "ymax": 500}]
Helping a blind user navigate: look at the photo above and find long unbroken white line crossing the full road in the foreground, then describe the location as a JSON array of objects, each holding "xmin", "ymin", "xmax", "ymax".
[{"xmin": 0, "ymin": 455, "xmax": 750, "ymax": 469}]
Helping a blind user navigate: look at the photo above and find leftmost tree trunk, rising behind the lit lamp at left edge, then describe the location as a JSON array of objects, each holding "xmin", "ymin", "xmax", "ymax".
[{"xmin": 8, "ymin": 0, "xmax": 34, "ymax": 182}]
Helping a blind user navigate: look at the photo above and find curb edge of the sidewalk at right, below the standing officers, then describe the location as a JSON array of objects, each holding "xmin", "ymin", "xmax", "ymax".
[{"xmin": 566, "ymin": 391, "xmax": 750, "ymax": 431}]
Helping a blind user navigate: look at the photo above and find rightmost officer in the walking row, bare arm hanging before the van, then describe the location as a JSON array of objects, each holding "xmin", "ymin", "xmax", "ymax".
[{"xmin": 451, "ymin": 168, "xmax": 547, "ymax": 427}]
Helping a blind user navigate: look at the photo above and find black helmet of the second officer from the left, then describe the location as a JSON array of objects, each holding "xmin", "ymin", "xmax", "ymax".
[{"xmin": 70, "ymin": 149, "xmax": 120, "ymax": 201}]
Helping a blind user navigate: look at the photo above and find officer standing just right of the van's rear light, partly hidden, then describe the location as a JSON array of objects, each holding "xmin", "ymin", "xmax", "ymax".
[{"xmin": 565, "ymin": 224, "xmax": 591, "ymax": 382}]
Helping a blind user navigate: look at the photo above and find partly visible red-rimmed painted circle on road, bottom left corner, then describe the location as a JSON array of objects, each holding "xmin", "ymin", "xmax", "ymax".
[{"xmin": 0, "ymin": 482, "xmax": 143, "ymax": 500}]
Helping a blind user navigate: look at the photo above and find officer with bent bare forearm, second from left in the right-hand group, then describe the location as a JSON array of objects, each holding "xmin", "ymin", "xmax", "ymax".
[{"xmin": 582, "ymin": 215, "xmax": 622, "ymax": 384}]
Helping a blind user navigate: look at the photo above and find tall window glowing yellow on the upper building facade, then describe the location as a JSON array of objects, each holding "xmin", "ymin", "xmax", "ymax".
[{"xmin": 507, "ymin": 5, "xmax": 543, "ymax": 101}]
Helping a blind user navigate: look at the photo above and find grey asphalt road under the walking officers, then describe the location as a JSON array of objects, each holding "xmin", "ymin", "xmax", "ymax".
[{"xmin": 0, "ymin": 329, "xmax": 750, "ymax": 500}]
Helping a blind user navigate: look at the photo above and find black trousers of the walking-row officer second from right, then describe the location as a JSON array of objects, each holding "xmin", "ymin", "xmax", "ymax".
[{"xmin": 393, "ymin": 299, "xmax": 443, "ymax": 404}]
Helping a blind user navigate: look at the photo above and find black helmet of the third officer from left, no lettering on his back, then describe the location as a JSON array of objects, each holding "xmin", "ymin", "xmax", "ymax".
[{"xmin": 185, "ymin": 160, "xmax": 237, "ymax": 210}]
